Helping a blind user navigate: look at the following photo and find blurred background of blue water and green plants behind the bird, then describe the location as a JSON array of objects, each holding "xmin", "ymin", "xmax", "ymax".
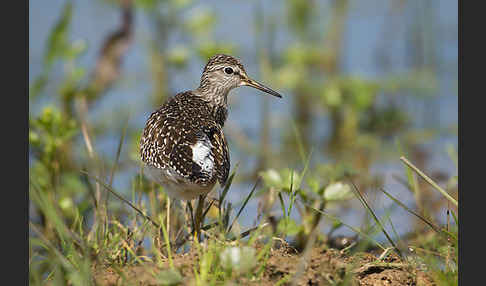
[{"xmin": 29, "ymin": 0, "xmax": 458, "ymax": 246}]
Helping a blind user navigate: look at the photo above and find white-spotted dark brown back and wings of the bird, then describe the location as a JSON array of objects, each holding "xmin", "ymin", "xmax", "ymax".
[{"xmin": 140, "ymin": 91, "xmax": 230, "ymax": 186}]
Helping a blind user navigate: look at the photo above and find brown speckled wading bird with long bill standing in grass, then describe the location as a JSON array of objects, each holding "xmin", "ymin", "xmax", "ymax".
[{"xmin": 140, "ymin": 54, "xmax": 282, "ymax": 239}]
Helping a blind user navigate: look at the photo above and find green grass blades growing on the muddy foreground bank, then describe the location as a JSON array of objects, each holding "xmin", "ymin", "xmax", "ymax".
[{"xmin": 29, "ymin": 155, "xmax": 458, "ymax": 285}]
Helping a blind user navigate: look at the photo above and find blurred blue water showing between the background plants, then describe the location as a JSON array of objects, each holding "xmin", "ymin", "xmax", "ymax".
[{"xmin": 29, "ymin": 0, "xmax": 458, "ymax": 242}]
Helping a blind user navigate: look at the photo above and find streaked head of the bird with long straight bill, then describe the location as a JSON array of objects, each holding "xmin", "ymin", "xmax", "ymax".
[{"xmin": 199, "ymin": 54, "xmax": 282, "ymax": 105}]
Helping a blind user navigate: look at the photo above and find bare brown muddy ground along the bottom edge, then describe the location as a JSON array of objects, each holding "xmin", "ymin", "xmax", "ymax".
[{"xmin": 94, "ymin": 241, "xmax": 435, "ymax": 286}]
